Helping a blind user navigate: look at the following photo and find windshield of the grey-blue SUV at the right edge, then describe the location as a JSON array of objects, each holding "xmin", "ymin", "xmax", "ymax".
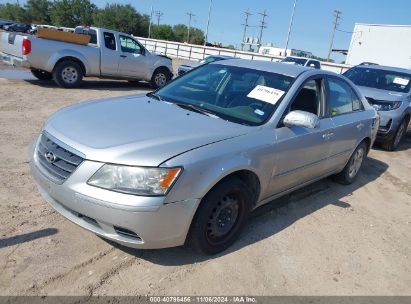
[{"xmin": 344, "ymin": 67, "xmax": 411, "ymax": 93}]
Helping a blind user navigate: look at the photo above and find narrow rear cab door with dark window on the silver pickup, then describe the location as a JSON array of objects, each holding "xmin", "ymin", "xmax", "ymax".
[{"xmin": 100, "ymin": 31, "xmax": 120, "ymax": 76}]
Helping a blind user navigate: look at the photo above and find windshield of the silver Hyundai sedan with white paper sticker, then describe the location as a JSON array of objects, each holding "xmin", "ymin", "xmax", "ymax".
[{"xmin": 156, "ymin": 64, "xmax": 294, "ymax": 126}]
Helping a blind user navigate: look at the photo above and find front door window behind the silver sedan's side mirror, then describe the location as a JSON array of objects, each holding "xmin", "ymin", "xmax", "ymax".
[{"xmin": 289, "ymin": 79, "xmax": 322, "ymax": 116}]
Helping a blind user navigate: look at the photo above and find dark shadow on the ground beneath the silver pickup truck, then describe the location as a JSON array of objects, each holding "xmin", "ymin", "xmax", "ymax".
[{"xmin": 24, "ymin": 79, "xmax": 153, "ymax": 92}]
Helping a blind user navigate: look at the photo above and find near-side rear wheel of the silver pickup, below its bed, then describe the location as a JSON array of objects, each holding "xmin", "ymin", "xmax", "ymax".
[{"xmin": 53, "ymin": 60, "xmax": 83, "ymax": 88}]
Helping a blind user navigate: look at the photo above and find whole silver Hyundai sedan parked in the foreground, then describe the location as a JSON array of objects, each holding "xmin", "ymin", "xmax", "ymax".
[{"xmin": 30, "ymin": 59, "xmax": 379, "ymax": 254}]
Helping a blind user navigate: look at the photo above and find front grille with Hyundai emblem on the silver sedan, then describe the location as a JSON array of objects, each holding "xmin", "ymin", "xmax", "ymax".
[{"xmin": 37, "ymin": 134, "xmax": 83, "ymax": 183}]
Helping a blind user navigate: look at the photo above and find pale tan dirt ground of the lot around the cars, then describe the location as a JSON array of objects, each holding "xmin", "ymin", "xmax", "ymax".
[{"xmin": 0, "ymin": 60, "xmax": 411, "ymax": 295}]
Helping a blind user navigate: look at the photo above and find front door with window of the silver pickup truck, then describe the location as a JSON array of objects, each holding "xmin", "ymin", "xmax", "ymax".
[{"xmin": 118, "ymin": 35, "xmax": 149, "ymax": 79}]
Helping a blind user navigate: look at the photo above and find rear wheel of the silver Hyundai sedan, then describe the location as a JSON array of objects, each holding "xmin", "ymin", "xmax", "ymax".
[{"xmin": 334, "ymin": 142, "xmax": 367, "ymax": 185}]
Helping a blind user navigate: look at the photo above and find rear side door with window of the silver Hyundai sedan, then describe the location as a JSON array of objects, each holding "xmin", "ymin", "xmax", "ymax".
[{"xmin": 326, "ymin": 76, "xmax": 372, "ymax": 168}]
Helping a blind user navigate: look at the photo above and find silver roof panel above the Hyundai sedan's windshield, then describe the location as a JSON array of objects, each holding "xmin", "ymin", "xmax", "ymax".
[{"xmin": 209, "ymin": 59, "xmax": 312, "ymax": 78}]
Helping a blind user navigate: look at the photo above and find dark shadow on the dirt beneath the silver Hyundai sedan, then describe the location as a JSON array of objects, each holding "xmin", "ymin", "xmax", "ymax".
[{"xmin": 108, "ymin": 157, "xmax": 388, "ymax": 266}]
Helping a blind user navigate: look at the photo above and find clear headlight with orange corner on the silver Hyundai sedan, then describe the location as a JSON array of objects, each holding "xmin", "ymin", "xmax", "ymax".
[{"xmin": 87, "ymin": 164, "xmax": 182, "ymax": 196}]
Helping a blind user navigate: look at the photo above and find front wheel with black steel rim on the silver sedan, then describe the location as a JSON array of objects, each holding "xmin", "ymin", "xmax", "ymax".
[{"xmin": 187, "ymin": 178, "xmax": 253, "ymax": 254}]
